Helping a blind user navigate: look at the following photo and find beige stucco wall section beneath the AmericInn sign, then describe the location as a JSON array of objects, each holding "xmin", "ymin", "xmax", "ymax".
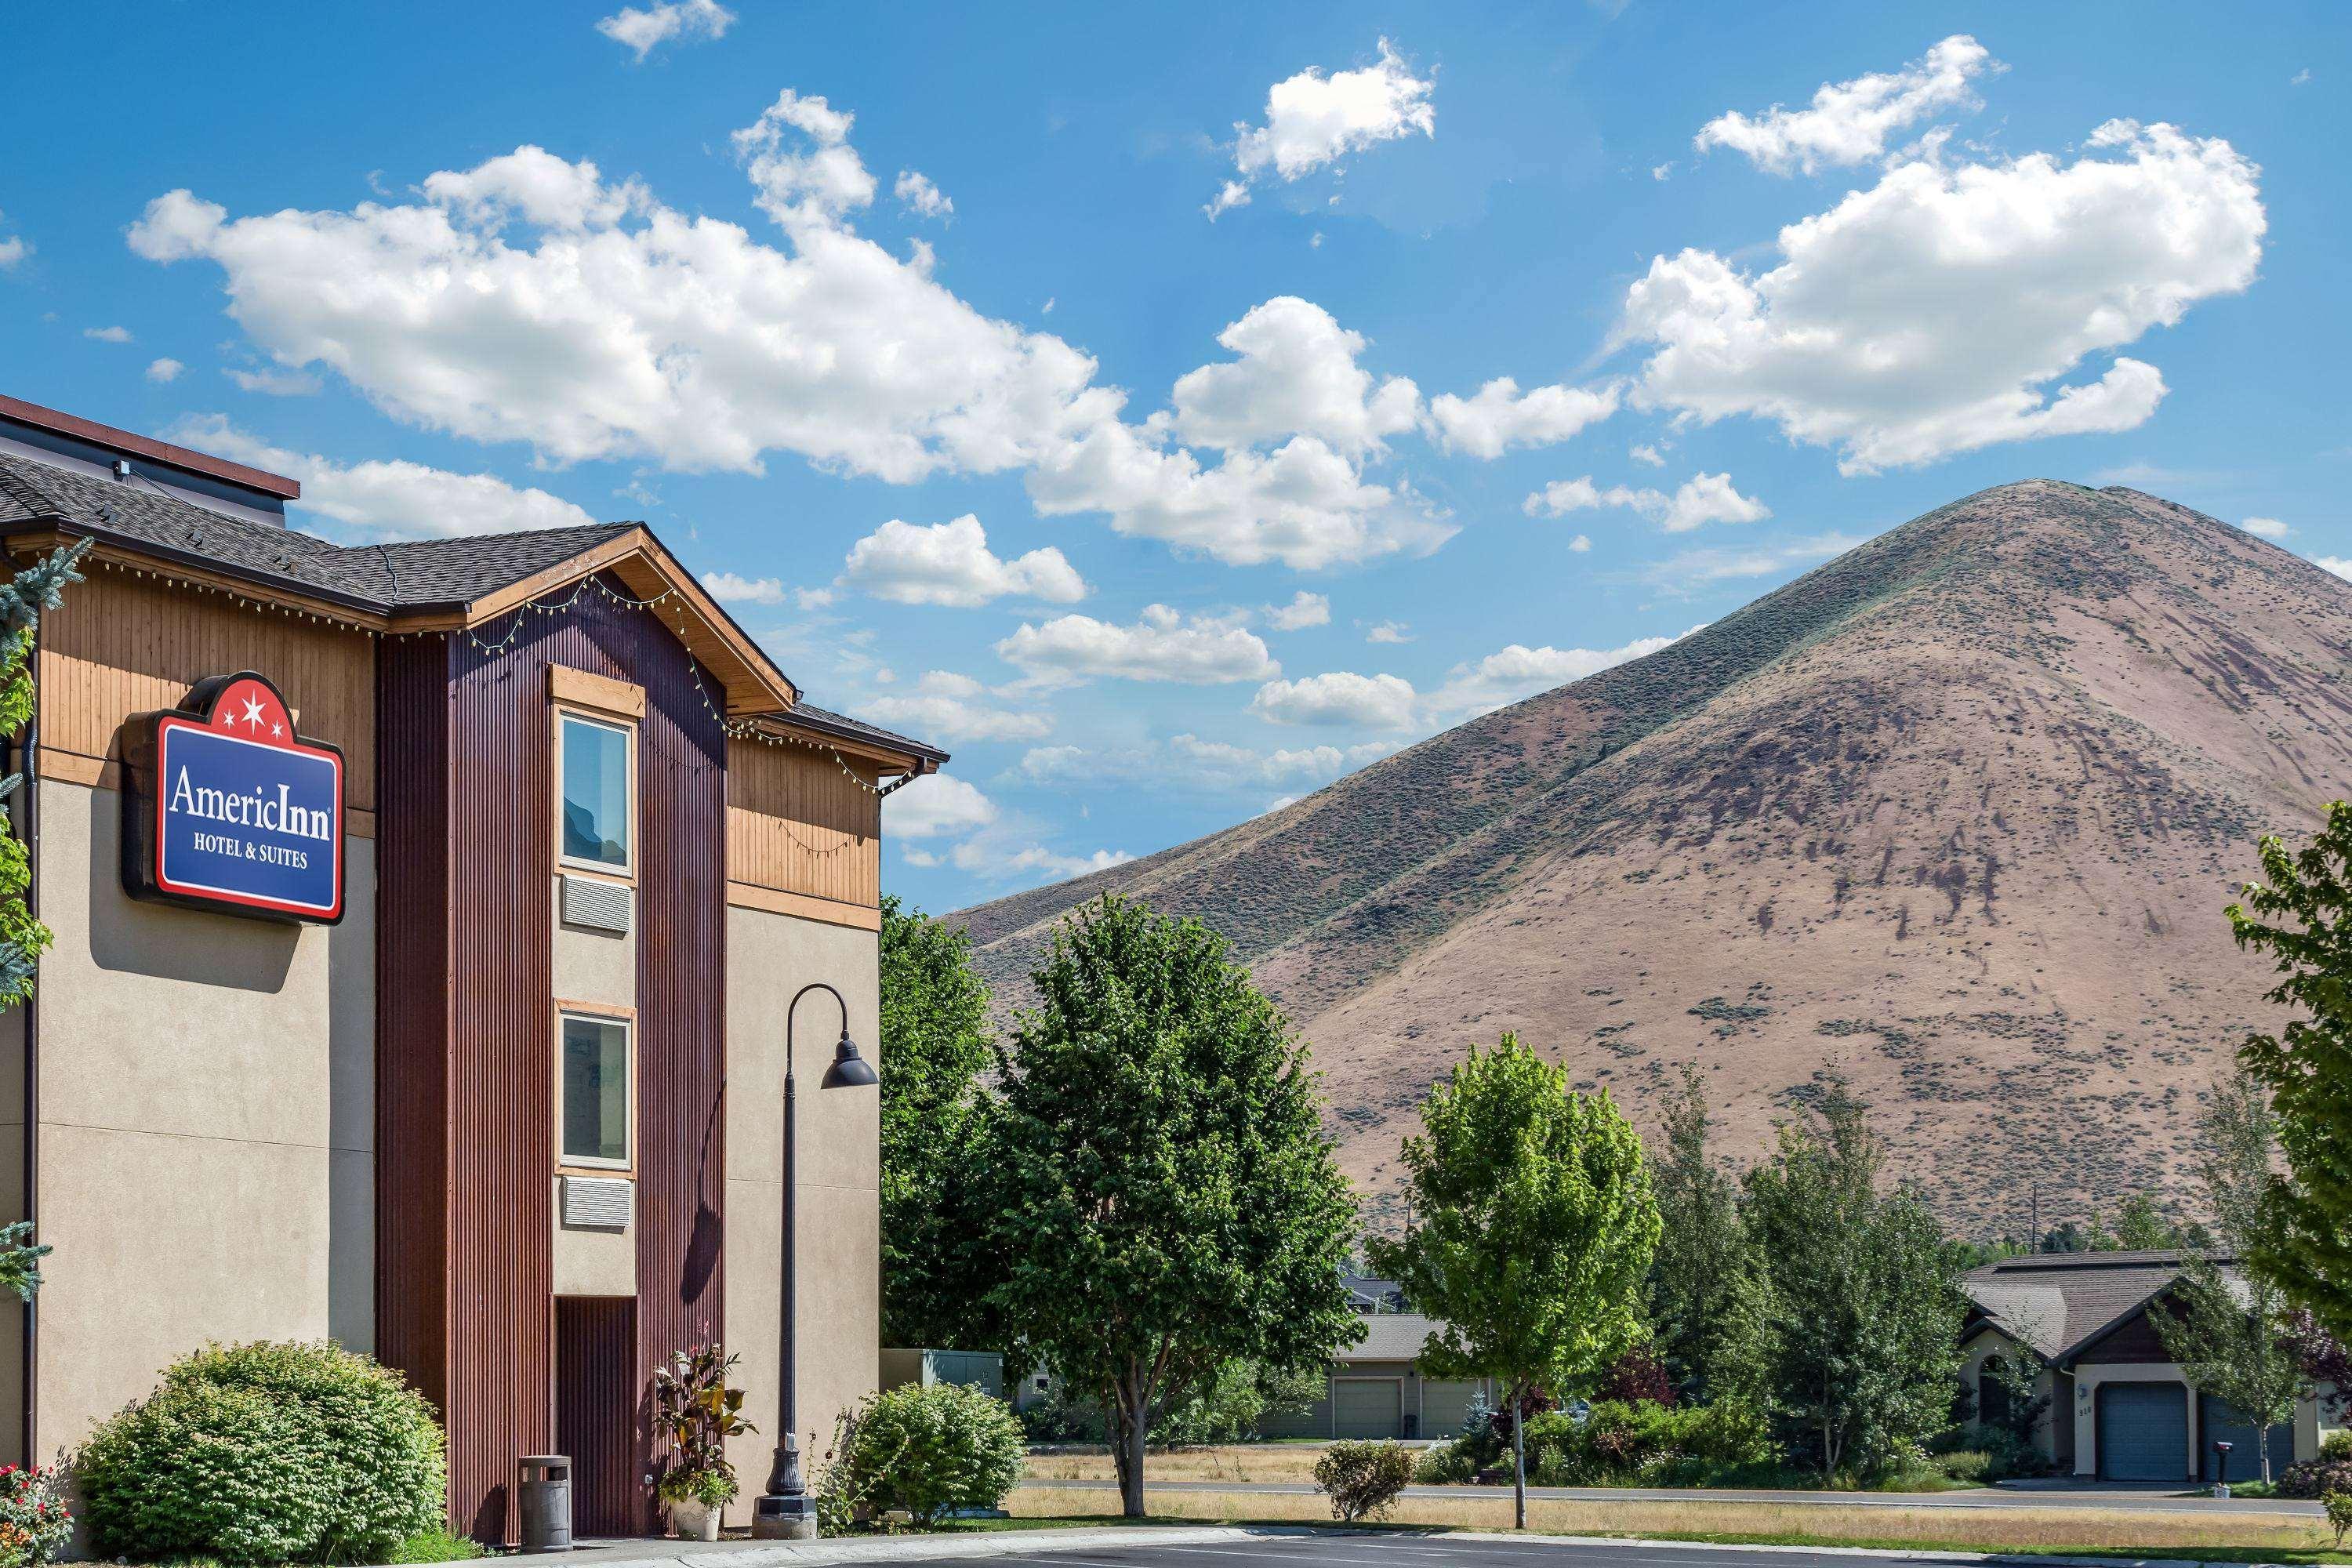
[{"xmin": 33, "ymin": 781, "xmax": 376, "ymax": 1457}]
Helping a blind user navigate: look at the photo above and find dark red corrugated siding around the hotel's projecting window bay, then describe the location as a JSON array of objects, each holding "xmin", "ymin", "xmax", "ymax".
[{"xmin": 379, "ymin": 586, "xmax": 727, "ymax": 1540}]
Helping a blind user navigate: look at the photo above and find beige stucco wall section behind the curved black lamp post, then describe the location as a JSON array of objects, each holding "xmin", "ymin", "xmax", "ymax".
[{"xmin": 727, "ymin": 907, "xmax": 882, "ymax": 1523}]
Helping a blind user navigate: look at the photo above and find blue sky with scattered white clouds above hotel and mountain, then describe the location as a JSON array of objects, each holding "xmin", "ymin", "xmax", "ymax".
[{"xmin": 0, "ymin": 0, "xmax": 2352, "ymax": 909}]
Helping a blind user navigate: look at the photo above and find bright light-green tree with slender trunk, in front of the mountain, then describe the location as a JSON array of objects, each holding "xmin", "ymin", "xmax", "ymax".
[{"xmin": 1371, "ymin": 1034, "xmax": 1658, "ymax": 1528}]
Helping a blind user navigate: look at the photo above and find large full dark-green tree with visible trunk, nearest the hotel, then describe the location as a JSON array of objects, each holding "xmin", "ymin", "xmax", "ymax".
[{"xmin": 990, "ymin": 898, "xmax": 1362, "ymax": 1519}]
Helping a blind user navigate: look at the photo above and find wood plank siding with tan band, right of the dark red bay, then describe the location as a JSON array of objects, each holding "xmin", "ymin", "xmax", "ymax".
[{"xmin": 727, "ymin": 739, "xmax": 882, "ymax": 909}]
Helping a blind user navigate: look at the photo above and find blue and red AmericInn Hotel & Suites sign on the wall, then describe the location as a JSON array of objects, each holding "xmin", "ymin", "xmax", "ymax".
[{"xmin": 122, "ymin": 675, "xmax": 343, "ymax": 924}]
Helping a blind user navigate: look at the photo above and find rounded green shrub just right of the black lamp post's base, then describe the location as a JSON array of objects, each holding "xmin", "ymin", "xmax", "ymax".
[{"xmin": 840, "ymin": 1382, "xmax": 1028, "ymax": 1523}]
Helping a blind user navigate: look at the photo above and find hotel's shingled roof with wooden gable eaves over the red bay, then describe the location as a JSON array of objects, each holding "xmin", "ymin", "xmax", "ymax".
[{"xmin": 0, "ymin": 449, "xmax": 948, "ymax": 771}]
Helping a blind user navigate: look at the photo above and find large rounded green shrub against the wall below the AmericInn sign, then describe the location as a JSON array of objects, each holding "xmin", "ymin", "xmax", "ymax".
[{"xmin": 75, "ymin": 1342, "xmax": 447, "ymax": 1563}]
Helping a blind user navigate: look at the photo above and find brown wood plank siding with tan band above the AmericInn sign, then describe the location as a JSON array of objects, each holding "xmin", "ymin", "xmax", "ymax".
[{"xmin": 40, "ymin": 567, "xmax": 376, "ymax": 818}]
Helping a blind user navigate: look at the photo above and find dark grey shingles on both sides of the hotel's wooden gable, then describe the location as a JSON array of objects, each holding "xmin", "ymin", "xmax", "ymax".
[{"xmin": 0, "ymin": 452, "xmax": 946, "ymax": 762}]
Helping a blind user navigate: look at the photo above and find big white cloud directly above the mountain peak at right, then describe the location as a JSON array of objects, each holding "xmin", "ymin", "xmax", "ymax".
[{"xmin": 1618, "ymin": 120, "xmax": 2265, "ymax": 473}]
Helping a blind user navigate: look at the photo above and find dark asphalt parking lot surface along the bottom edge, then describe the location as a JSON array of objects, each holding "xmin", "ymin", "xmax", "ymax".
[{"xmin": 896, "ymin": 1530, "xmax": 2042, "ymax": 1568}]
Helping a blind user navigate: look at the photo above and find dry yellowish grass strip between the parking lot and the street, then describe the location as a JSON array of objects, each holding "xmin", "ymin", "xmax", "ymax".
[{"xmin": 1004, "ymin": 1486, "xmax": 2352, "ymax": 1563}]
